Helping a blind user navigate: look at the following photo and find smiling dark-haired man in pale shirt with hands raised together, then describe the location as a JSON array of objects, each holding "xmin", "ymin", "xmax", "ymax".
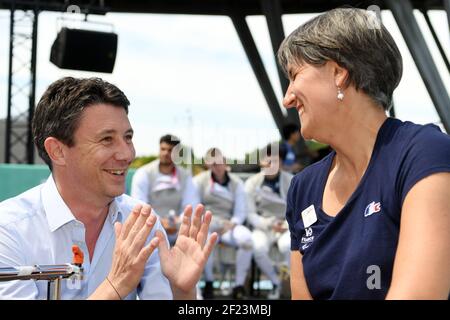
[{"xmin": 0, "ymin": 77, "xmax": 217, "ymax": 299}]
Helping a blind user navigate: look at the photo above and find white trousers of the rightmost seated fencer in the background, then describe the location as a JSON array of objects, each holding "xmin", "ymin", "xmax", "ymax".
[{"xmin": 252, "ymin": 229, "xmax": 290, "ymax": 285}]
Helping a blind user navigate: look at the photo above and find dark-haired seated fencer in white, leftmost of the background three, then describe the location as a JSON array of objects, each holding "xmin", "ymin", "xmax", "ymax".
[{"xmin": 131, "ymin": 134, "xmax": 200, "ymax": 245}]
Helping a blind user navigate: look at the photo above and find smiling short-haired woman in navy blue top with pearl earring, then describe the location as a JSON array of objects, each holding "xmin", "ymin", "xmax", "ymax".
[{"xmin": 278, "ymin": 8, "xmax": 450, "ymax": 299}]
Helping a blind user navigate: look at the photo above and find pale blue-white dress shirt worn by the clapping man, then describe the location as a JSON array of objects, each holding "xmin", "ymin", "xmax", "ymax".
[{"xmin": 0, "ymin": 176, "xmax": 173, "ymax": 299}]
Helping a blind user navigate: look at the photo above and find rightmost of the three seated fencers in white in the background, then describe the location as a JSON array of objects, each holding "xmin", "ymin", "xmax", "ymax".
[{"xmin": 245, "ymin": 144, "xmax": 293, "ymax": 299}]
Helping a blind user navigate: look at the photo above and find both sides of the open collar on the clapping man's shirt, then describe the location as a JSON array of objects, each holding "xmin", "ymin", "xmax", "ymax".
[{"xmin": 42, "ymin": 175, "xmax": 122, "ymax": 232}]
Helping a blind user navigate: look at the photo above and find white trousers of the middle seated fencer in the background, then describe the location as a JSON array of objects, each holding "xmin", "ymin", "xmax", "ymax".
[{"xmin": 205, "ymin": 225, "xmax": 253, "ymax": 286}]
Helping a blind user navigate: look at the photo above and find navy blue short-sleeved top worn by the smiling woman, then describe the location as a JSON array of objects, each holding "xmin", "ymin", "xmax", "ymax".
[{"xmin": 286, "ymin": 118, "xmax": 450, "ymax": 299}]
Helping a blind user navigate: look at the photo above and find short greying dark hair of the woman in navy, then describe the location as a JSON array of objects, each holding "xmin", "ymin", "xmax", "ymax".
[{"xmin": 278, "ymin": 8, "xmax": 403, "ymax": 110}]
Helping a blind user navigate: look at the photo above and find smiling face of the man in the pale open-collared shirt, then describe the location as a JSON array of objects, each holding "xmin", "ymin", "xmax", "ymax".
[{"xmin": 64, "ymin": 104, "xmax": 135, "ymax": 199}]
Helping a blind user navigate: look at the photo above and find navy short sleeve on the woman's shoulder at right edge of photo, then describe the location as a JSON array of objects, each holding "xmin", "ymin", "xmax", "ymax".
[{"xmin": 397, "ymin": 125, "xmax": 450, "ymax": 206}]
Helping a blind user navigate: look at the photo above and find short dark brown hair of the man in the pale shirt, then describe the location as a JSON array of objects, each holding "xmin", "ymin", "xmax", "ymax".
[{"xmin": 32, "ymin": 77, "xmax": 130, "ymax": 170}]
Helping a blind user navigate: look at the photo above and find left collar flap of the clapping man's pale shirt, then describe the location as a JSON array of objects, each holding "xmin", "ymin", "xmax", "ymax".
[{"xmin": 41, "ymin": 175, "xmax": 76, "ymax": 232}]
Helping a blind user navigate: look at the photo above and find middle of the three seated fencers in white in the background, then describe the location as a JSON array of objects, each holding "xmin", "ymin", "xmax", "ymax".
[{"xmin": 194, "ymin": 148, "xmax": 253, "ymax": 299}]
